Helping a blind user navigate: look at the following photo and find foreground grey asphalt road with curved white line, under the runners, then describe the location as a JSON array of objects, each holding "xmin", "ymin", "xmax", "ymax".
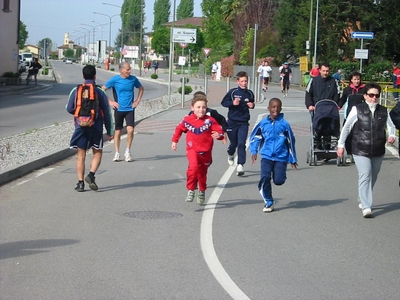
[{"xmin": 0, "ymin": 82, "xmax": 400, "ymax": 300}]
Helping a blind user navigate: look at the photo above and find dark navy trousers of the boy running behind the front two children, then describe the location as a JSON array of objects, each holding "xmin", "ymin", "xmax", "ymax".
[{"xmin": 226, "ymin": 120, "xmax": 249, "ymax": 165}]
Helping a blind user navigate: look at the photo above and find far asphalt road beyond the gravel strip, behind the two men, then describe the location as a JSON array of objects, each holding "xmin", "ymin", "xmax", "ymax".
[{"xmin": 0, "ymin": 60, "xmax": 167, "ymax": 137}]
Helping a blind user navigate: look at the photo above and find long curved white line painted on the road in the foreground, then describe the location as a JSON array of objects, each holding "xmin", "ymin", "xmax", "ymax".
[{"xmin": 200, "ymin": 166, "xmax": 250, "ymax": 300}]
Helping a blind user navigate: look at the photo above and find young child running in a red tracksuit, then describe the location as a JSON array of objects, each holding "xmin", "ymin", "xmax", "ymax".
[{"xmin": 171, "ymin": 95, "xmax": 224, "ymax": 205}]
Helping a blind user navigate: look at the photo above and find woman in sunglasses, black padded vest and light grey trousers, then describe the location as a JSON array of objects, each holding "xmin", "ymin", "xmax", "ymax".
[{"xmin": 337, "ymin": 83, "xmax": 396, "ymax": 218}]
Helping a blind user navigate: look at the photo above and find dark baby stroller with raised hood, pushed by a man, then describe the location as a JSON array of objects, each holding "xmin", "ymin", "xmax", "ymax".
[{"xmin": 307, "ymin": 99, "xmax": 344, "ymax": 166}]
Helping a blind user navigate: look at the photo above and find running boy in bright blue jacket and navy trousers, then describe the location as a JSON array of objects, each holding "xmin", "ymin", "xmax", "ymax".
[{"xmin": 249, "ymin": 98, "xmax": 297, "ymax": 213}]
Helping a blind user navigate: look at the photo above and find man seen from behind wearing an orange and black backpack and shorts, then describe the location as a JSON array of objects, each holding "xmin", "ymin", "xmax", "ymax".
[{"xmin": 67, "ymin": 65, "xmax": 114, "ymax": 192}]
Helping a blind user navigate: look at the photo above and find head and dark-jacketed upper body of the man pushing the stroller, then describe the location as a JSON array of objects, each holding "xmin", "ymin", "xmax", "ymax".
[{"xmin": 305, "ymin": 63, "xmax": 340, "ymax": 111}]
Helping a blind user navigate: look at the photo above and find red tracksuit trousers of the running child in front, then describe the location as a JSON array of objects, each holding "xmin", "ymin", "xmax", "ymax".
[{"xmin": 186, "ymin": 149, "xmax": 212, "ymax": 192}]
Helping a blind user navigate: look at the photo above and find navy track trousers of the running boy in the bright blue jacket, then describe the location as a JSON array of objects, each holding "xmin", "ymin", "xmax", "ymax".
[{"xmin": 258, "ymin": 158, "xmax": 287, "ymax": 205}]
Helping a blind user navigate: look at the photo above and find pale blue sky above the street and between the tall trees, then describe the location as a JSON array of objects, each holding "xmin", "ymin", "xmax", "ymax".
[{"xmin": 21, "ymin": 0, "xmax": 202, "ymax": 47}]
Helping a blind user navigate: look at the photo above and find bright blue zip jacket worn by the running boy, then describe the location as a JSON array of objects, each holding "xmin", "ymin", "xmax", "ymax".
[{"xmin": 249, "ymin": 113, "xmax": 297, "ymax": 164}]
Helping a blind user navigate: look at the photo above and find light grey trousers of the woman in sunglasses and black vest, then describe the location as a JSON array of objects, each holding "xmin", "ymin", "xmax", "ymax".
[{"xmin": 353, "ymin": 155, "xmax": 383, "ymax": 209}]
